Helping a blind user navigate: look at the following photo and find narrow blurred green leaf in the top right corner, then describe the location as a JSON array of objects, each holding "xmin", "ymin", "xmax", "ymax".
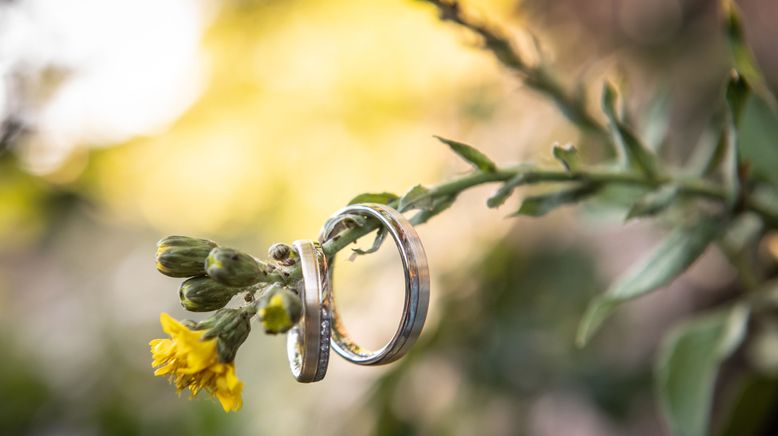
[{"xmin": 722, "ymin": 0, "xmax": 778, "ymax": 111}]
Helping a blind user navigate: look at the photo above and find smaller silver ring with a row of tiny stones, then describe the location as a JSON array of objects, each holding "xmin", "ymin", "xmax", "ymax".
[{"xmin": 286, "ymin": 241, "xmax": 332, "ymax": 383}]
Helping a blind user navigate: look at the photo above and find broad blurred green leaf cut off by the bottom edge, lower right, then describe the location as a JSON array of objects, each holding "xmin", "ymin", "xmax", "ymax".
[{"xmin": 655, "ymin": 305, "xmax": 749, "ymax": 436}]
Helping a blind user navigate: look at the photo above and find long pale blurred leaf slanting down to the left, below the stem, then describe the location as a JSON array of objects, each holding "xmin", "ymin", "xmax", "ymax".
[{"xmin": 576, "ymin": 217, "xmax": 720, "ymax": 346}]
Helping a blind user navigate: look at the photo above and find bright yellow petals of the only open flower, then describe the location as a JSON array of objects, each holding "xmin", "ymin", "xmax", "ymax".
[{"xmin": 149, "ymin": 313, "xmax": 243, "ymax": 412}]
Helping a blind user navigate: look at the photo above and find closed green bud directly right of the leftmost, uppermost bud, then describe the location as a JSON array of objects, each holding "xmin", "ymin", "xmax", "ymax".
[{"xmin": 205, "ymin": 247, "xmax": 267, "ymax": 287}]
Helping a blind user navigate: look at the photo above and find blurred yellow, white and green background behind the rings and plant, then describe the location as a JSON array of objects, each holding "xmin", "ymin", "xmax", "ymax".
[{"xmin": 0, "ymin": 0, "xmax": 778, "ymax": 436}]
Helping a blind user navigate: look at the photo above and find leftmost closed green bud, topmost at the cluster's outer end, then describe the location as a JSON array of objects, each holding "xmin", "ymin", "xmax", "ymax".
[{"xmin": 156, "ymin": 236, "xmax": 217, "ymax": 277}]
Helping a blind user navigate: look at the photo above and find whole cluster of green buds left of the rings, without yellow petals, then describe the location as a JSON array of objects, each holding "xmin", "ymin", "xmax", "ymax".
[{"xmin": 156, "ymin": 236, "xmax": 302, "ymax": 362}]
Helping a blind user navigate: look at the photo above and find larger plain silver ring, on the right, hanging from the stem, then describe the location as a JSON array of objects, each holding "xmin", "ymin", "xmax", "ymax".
[{"xmin": 319, "ymin": 203, "xmax": 430, "ymax": 365}]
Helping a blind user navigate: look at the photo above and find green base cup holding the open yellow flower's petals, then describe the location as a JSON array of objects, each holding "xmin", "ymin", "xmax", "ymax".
[{"xmin": 199, "ymin": 308, "xmax": 253, "ymax": 363}]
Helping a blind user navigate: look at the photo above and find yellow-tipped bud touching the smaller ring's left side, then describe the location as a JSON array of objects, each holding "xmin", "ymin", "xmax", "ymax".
[{"xmin": 257, "ymin": 283, "xmax": 303, "ymax": 335}]
